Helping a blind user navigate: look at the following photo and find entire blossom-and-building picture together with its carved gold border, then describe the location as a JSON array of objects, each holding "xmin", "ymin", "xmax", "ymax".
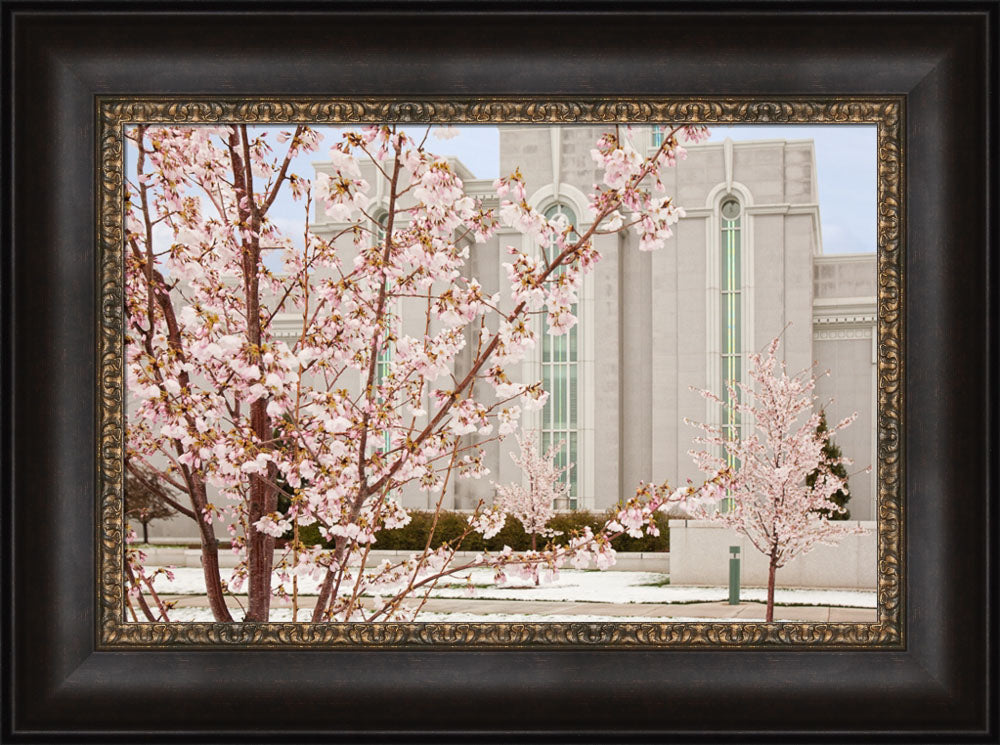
[{"xmin": 103, "ymin": 106, "xmax": 892, "ymax": 647}]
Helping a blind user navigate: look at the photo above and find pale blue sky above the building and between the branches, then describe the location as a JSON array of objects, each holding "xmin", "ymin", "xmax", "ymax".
[{"xmin": 130, "ymin": 124, "xmax": 877, "ymax": 254}]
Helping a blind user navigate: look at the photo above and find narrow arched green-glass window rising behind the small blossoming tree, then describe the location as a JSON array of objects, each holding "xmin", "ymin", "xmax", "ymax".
[{"xmin": 719, "ymin": 199, "xmax": 743, "ymax": 511}]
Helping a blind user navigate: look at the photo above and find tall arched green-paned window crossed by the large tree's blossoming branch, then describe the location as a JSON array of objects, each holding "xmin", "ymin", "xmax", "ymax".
[{"xmin": 541, "ymin": 204, "xmax": 580, "ymax": 509}]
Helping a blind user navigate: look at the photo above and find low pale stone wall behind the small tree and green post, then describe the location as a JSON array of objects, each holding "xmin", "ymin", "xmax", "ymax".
[{"xmin": 670, "ymin": 520, "xmax": 878, "ymax": 590}]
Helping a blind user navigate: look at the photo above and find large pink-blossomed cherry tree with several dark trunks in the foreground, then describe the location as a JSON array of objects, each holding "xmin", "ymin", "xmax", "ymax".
[{"xmin": 125, "ymin": 120, "xmax": 723, "ymax": 622}]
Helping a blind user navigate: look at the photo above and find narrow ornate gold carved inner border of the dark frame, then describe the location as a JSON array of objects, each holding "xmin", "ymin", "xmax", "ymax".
[{"xmin": 95, "ymin": 96, "xmax": 906, "ymax": 649}]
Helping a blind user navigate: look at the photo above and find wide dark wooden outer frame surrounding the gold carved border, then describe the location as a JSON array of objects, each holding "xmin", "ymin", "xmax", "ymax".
[{"xmin": 0, "ymin": 2, "xmax": 997, "ymax": 742}]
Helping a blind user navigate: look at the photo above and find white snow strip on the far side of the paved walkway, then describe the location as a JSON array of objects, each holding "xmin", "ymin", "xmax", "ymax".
[{"xmin": 148, "ymin": 567, "xmax": 877, "ymax": 608}]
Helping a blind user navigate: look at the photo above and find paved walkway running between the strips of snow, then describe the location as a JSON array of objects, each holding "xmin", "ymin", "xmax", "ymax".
[{"xmin": 163, "ymin": 595, "xmax": 878, "ymax": 623}]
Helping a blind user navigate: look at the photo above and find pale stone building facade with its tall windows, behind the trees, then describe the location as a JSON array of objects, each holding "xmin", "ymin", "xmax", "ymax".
[{"xmin": 146, "ymin": 125, "xmax": 877, "ymax": 533}]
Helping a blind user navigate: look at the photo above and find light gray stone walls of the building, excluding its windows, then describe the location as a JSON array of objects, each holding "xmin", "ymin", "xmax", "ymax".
[{"xmin": 304, "ymin": 126, "xmax": 874, "ymax": 517}]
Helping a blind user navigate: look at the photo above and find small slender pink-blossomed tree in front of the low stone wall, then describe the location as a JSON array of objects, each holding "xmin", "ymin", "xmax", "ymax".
[{"xmin": 687, "ymin": 336, "xmax": 865, "ymax": 622}]
